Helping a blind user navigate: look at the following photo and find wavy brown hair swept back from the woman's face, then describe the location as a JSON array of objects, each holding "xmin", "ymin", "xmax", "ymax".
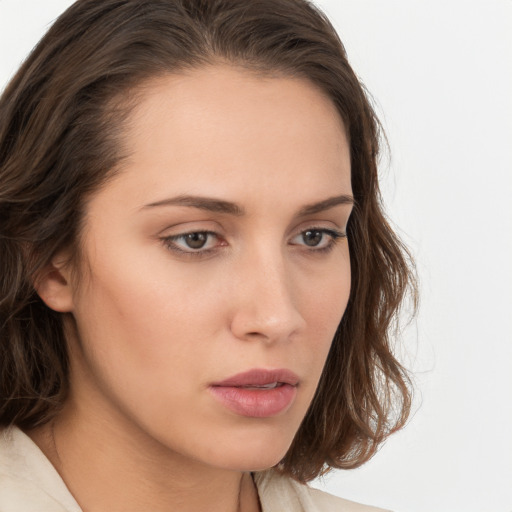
[{"xmin": 0, "ymin": 0, "xmax": 415, "ymax": 481}]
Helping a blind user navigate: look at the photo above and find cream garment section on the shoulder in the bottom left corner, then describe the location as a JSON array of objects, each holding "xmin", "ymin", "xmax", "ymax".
[{"xmin": 0, "ymin": 427, "xmax": 80, "ymax": 512}]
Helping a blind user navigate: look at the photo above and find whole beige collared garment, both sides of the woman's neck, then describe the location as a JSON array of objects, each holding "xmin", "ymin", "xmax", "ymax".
[{"xmin": 0, "ymin": 428, "xmax": 384, "ymax": 512}]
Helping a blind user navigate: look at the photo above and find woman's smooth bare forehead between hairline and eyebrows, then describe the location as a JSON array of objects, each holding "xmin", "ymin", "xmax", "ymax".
[{"xmin": 95, "ymin": 65, "xmax": 351, "ymax": 212}]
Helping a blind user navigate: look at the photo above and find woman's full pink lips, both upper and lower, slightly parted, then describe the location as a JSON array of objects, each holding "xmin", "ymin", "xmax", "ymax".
[{"xmin": 208, "ymin": 369, "xmax": 299, "ymax": 418}]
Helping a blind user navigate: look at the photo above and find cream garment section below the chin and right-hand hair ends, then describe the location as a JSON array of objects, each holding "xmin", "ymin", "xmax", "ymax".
[{"xmin": 254, "ymin": 470, "xmax": 385, "ymax": 512}]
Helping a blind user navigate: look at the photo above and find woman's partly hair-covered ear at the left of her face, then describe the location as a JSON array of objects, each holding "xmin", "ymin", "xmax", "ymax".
[{"xmin": 34, "ymin": 254, "xmax": 73, "ymax": 313}]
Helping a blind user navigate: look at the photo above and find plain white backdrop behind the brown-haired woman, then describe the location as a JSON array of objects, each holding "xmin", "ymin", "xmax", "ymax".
[{"xmin": 0, "ymin": 0, "xmax": 512, "ymax": 512}]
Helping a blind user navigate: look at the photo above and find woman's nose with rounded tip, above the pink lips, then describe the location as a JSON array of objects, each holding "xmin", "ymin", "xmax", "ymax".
[{"xmin": 231, "ymin": 248, "xmax": 306, "ymax": 343}]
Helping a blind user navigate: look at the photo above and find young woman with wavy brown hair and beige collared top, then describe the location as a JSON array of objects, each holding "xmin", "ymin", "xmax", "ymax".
[{"xmin": 0, "ymin": 0, "xmax": 412, "ymax": 512}]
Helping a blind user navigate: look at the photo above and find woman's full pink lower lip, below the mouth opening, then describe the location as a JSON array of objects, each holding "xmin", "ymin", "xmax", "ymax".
[{"xmin": 209, "ymin": 384, "xmax": 297, "ymax": 418}]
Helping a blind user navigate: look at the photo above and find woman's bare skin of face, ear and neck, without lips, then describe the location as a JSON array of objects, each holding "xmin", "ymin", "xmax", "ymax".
[{"xmin": 30, "ymin": 65, "xmax": 352, "ymax": 512}]
